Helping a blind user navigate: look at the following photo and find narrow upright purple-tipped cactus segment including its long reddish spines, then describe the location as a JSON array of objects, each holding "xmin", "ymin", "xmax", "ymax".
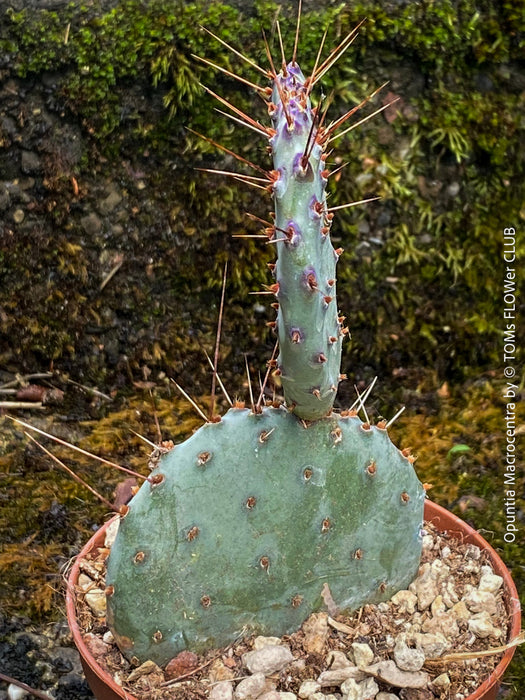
[{"xmin": 190, "ymin": 12, "xmax": 396, "ymax": 420}]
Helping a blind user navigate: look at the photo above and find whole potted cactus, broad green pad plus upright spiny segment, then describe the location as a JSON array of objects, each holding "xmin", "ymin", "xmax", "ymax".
[{"xmin": 106, "ymin": 17, "xmax": 424, "ymax": 664}]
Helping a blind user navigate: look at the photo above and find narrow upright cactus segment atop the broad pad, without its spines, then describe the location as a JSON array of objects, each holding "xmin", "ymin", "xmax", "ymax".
[{"xmin": 270, "ymin": 63, "xmax": 343, "ymax": 420}]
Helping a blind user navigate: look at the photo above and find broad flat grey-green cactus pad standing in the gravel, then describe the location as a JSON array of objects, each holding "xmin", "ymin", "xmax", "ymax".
[{"xmin": 107, "ymin": 408, "xmax": 424, "ymax": 664}]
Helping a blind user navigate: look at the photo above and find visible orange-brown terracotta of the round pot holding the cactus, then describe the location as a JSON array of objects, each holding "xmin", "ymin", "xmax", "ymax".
[{"xmin": 66, "ymin": 501, "xmax": 521, "ymax": 700}]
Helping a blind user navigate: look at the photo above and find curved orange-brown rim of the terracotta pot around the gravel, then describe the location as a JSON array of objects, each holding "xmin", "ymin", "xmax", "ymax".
[{"xmin": 66, "ymin": 499, "xmax": 521, "ymax": 700}]
